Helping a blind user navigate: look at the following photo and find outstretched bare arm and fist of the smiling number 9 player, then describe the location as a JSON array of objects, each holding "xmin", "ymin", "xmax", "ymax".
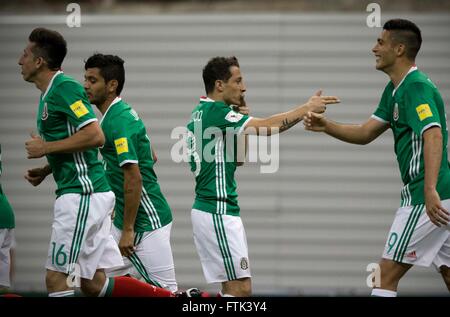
[{"xmin": 303, "ymin": 112, "xmax": 389, "ymax": 145}]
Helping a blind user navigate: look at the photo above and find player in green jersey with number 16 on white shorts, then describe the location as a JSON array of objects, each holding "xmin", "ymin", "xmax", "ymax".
[{"xmin": 19, "ymin": 28, "xmax": 185, "ymax": 297}]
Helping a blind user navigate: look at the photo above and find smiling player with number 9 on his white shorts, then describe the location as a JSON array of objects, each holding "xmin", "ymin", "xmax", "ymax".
[{"xmin": 304, "ymin": 19, "xmax": 450, "ymax": 296}]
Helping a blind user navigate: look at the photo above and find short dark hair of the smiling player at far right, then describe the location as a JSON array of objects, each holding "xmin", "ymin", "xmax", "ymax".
[{"xmin": 383, "ymin": 19, "xmax": 422, "ymax": 60}]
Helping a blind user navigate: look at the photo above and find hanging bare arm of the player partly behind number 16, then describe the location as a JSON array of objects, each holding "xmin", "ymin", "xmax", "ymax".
[{"xmin": 119, "ymin": 164, "xmax": 142, "ymax": 256}]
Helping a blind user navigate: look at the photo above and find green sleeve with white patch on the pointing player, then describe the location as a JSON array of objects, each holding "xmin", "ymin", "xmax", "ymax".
[{"xmin": 210, "ymin": 107, "xmax": 252, "ymax": 135}]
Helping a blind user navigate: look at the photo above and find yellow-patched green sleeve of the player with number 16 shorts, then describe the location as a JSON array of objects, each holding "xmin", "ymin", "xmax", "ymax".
[{"xmin": 54, "ymin": 81, "xmax": 97, "ymax": 131}]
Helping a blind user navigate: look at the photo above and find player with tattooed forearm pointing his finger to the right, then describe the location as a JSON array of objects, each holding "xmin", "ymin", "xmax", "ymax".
[{"xmin": 187, "ymin": 57, "xmax": 338, "ymax": 296}]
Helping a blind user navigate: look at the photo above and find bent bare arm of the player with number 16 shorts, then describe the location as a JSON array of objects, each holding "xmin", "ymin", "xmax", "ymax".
[{"xmin": 25, "ymin": 121, "xmax": 105, "ymax": 159}]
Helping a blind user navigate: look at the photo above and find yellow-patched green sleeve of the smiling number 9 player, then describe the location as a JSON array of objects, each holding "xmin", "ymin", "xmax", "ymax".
[{"xmin": 404, "ymin": 82, "xmax": 441, "ymax": 136}]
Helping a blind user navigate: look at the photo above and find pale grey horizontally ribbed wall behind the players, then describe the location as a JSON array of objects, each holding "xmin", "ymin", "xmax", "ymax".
[{"xmin": 0, "ymin": 0, "xmax": 450, "ymax": 296}]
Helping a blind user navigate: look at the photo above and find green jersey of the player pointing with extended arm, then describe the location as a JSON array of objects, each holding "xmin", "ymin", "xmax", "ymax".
[{"xmin": 186, "ymin": 97, "xmax": 251, "ymax": 216}]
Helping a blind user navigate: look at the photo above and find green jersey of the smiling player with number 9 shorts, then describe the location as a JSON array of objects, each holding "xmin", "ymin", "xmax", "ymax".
[{"xmin": 372, "ymin": 67, "xmax": 450, "ymax": 207}]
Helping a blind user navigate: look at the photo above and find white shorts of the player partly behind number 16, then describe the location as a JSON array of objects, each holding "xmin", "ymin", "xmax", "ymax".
[{"xmin": 105, "ymin": 223, "xmax": 178, "ymax": 292}]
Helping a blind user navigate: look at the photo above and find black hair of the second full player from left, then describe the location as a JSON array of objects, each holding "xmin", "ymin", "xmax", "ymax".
[{"xmin": 84, "ymin": 53, "xmax": 125, "ymax": 95}]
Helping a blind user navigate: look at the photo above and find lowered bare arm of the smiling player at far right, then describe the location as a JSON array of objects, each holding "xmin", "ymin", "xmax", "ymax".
[{"xmin": 423, "ymin": 126, "xmax": 450, "ymax": 227}]
